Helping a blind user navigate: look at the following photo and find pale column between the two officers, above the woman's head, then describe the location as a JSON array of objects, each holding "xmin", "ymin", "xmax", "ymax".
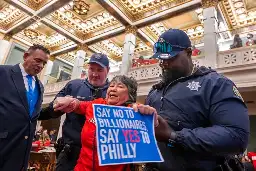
[{"xmin": 121, "ymin": 26, "xmax": 137, "ymax": 75}]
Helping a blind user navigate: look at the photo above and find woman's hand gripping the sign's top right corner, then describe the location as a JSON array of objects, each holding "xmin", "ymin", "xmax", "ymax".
[{"xmin": 132, "ymin": 104, "xmax": 159, "ymax": 127}]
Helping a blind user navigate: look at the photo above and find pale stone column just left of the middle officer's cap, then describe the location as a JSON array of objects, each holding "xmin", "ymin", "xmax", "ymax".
[{"xmin": 71, "ymin": 45, "xmax": 88, "ymax": 80}]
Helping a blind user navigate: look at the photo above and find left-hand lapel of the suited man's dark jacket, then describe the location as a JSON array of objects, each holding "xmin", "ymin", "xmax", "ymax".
[{"xmin": 11, "ymin": 65, "xmax": 29, "ymax": 117}]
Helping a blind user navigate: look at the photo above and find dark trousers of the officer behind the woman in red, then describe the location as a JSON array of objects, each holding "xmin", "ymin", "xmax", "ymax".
[{"xmin": 56, "ymin": 144, "xmax": 81, "ymax": 171}]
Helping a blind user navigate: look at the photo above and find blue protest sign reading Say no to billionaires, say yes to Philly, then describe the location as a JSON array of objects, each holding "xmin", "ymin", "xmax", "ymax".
[{"xmin": 93, "ymin": 104, "xmax": 163, "ymax": 166}]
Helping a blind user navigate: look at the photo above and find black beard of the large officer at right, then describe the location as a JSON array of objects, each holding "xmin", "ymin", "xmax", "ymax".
[{"xmin": 162, "ymin": 68, "xmax": 186, "ymax": 84}]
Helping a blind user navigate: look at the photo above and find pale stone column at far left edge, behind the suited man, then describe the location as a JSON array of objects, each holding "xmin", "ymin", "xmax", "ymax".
[{"xmin": 0, "ymin": 35, "xmax": 11, "ymax": 65}]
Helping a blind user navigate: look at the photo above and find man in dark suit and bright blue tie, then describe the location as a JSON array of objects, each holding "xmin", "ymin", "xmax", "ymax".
[{"xmin": 0, "ymin": 45, "xmax": 50, "ymax": 171}]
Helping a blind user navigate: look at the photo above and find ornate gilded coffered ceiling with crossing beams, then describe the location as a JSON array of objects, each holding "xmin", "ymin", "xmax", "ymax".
[{"xmin": 0, "ymin": 0, "xmax": 256, "ymax": 66}]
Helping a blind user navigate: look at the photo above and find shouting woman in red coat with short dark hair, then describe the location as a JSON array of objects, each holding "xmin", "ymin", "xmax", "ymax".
[{"xmin": 54, "ymin": 76, "xmax": 158, "ymax": 171}]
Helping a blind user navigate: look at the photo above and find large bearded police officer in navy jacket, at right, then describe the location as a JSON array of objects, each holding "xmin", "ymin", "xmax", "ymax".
[{"xmin": 146, "ymin": 29, "xmax": 249, "ymax": 171}]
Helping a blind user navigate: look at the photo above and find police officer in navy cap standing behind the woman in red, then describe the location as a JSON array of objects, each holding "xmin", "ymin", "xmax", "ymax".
[{"xmin": 39, "ymin": 53, "xmax": 109, "ymax": 171}]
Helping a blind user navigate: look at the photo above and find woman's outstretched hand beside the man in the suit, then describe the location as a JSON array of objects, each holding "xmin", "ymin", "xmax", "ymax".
[{"xmin": 53, "ymin": 96, "xmax": 79, "ymax": 113}]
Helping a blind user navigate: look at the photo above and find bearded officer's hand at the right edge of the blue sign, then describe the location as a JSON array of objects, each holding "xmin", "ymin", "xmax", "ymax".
[{"xmin": 155, "ymin": 115, "xmax": 173, "ymax": 142}]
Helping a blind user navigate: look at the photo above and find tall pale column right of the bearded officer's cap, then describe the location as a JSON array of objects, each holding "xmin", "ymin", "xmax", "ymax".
[{"xmin": 202, "ymin": 0, "xmax": 219, "ymax": 69}]
